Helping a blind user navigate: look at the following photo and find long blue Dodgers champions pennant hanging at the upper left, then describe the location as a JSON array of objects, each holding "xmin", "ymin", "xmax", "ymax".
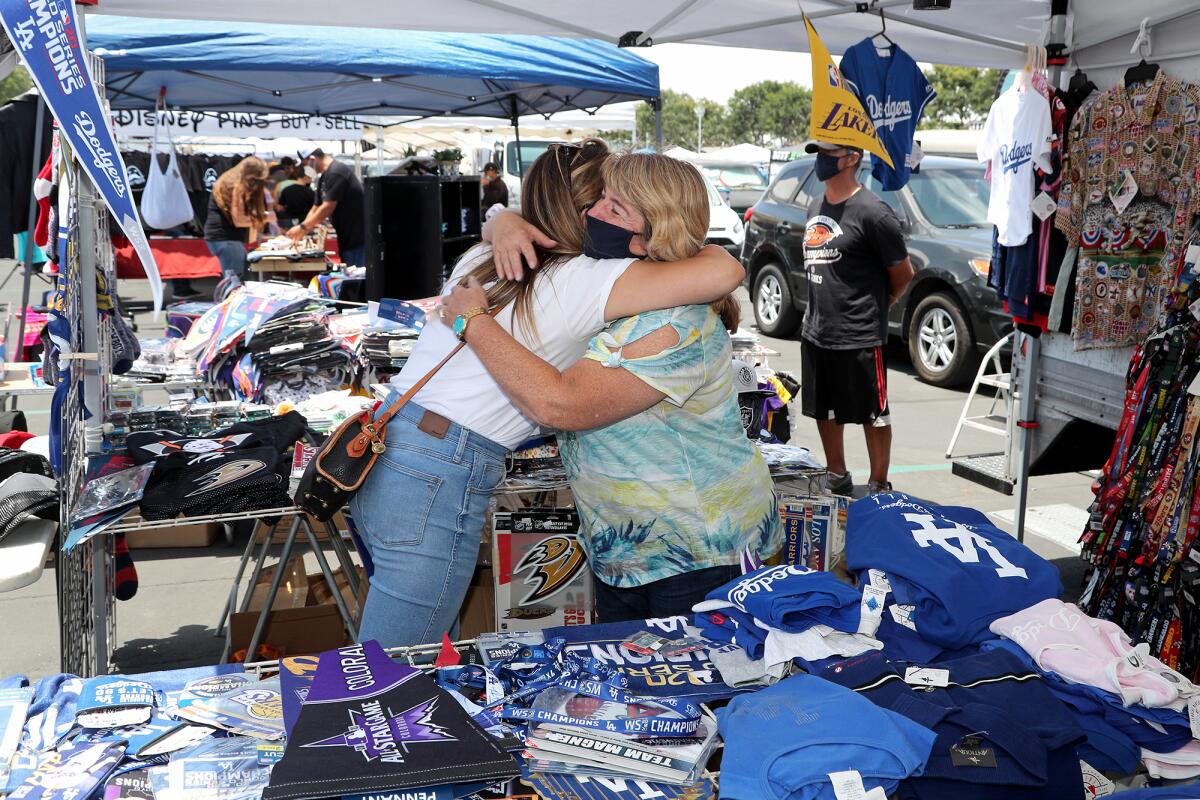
[{"xmin": 0, "ymin": 0, "xmax": 162, "ymax": 311}]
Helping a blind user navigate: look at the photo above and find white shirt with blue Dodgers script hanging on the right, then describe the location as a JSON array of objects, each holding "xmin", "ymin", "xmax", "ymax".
[{"xmin": 978, "ymin": 89, "xmax": 1051, "ymax": 247}]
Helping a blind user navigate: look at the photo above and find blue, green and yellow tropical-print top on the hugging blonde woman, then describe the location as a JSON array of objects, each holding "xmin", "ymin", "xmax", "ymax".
[{"xmin": 559, "ymin": 306, "xmax": 782, "ymax": 588}]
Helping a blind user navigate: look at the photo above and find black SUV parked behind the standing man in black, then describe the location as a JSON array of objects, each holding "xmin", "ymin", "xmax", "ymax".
[{"xmin": 742, "ymin": 156, "xmax": 1010, "ymax": 386}]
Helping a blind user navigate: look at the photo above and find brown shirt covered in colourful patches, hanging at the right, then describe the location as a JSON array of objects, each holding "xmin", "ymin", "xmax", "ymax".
[{"xmin": 1055, "ymin": 72, "xmax": 1200, "ymax": 349}]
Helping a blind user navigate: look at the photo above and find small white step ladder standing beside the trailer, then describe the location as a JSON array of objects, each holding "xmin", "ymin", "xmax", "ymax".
[{"xmin": 946, "ymin": 333, "xmax": 1016, "ymax": 494}]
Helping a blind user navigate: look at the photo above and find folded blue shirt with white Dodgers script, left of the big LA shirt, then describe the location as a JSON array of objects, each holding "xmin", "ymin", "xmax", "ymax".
[{"xmin": 695, "ymin": 564, "xmax": 863, "ymax": 633}]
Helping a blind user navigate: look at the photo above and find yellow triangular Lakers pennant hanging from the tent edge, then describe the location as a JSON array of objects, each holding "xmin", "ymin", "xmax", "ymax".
[{"xmin": 804, "ymin": 17, "xmax": 895, "ymax": 169}]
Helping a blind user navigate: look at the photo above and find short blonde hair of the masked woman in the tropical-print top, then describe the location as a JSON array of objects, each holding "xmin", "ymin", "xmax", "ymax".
[{"xmin": 601, "ymin": 152, "xmax": 742, "ymax": 332}]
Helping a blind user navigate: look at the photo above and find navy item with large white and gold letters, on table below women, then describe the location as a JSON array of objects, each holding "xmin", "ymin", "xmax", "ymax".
[{"xmin": 544, "ymin": 616, "xmax": 750, "ymax": 703}]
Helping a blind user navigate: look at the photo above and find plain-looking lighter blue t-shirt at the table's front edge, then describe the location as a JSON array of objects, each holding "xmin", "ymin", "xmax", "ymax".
[{"xmin": 716, "ymin": 674, "xmax": 935, "ymax": 800}]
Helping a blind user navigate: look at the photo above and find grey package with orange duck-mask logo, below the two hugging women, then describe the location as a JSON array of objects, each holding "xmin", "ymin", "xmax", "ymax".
[{"xmin": 492, "ymin": 509, "xmax": 594, "ymax": 631}]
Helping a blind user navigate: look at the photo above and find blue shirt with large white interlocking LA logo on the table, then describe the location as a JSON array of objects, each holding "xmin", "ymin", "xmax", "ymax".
[{"xmin": 846, "ymin": 492, "xmax": 1062, "ymax": 649}]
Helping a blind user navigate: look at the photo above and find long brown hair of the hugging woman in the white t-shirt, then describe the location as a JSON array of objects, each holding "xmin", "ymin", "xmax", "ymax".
[{"xmin": 460, "ymin": 139, "xmax": 608, "ymax": 337}]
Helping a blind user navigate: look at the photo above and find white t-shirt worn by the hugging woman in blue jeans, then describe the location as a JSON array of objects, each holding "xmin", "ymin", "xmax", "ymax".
[{"xmin": 391, "ymin": 245, "xmax": 634, "ymax": 450}]
